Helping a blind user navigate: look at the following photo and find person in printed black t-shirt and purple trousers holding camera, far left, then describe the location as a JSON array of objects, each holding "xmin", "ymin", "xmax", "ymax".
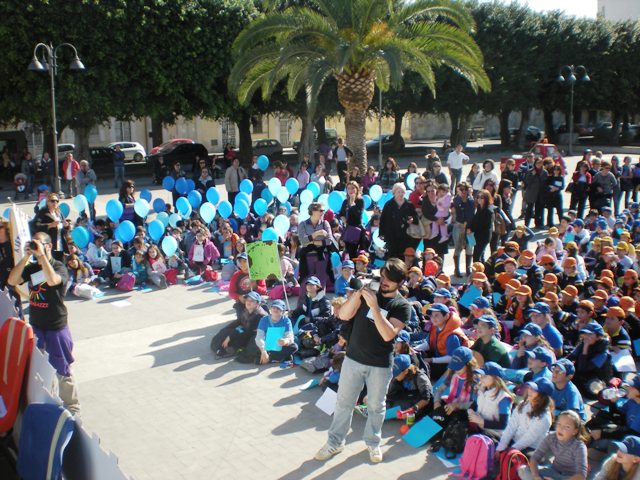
[{"xmin": 7, "ymin": 232, "xmax": 80, "ymax": 415}]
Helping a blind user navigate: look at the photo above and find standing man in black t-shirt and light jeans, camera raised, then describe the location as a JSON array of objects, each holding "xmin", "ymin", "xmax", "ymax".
[{"xmin": 315, "ymin": 258, "xmax": 411, "ymax": 463}]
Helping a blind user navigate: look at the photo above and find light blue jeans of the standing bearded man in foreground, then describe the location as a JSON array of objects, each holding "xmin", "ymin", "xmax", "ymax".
[{"xmin": 329, "ymin": 357, "xmax": 392, "ymax": 447}]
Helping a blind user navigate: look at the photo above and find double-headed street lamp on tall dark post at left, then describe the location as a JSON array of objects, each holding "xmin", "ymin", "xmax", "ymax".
[{"xmin": 28, "ymin": 43, "xmax": 84, "ymax": 193}]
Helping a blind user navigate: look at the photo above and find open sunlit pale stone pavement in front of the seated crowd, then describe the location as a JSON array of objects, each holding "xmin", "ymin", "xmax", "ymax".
[{"xmin": 67, "ymin": 285, "xmax": 446, "ymax": 480}]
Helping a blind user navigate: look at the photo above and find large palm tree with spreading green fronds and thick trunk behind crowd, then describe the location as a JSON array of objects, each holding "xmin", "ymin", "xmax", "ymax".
[{"xmin": 229, "ymin": 0, "xmax": 490, "ymax": 172}]
